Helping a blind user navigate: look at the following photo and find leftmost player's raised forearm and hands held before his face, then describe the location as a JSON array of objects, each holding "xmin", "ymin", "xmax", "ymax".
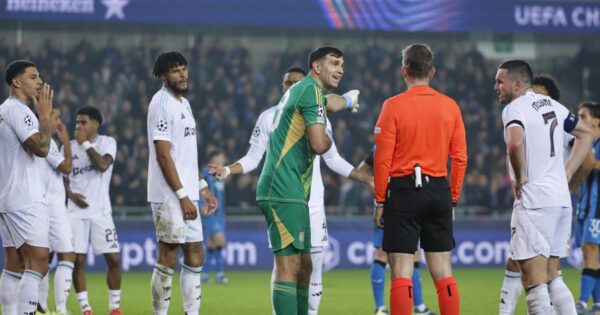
[{"xmin": 24, "ymin": 83, "xmax": 56, "ymax": 157}]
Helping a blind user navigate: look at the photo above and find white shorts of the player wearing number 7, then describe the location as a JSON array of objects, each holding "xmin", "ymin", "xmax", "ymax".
[{"xmin": 510, "ymin": 204, "xmax": 572, "ymax": 260}]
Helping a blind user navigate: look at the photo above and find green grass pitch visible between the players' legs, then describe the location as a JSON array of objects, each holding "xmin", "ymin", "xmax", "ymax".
[{"xmin": 39, "ymin": 269, "xmax": 580, "ymax": 315}]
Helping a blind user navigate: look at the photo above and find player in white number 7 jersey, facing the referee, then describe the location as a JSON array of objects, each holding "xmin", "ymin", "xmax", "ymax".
[{"xmin": 494, "ymin": 60, "xmax": 593, "ymax": 315}]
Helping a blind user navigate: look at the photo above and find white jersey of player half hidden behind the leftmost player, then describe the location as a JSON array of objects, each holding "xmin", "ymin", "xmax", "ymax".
[{"xmin": 40, "ymin": 139, "xmax": 65, "ymax": 204}]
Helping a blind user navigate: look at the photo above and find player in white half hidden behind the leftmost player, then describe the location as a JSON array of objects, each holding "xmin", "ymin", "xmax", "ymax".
[{"xmin": 38, "ymin": 108, "xmax": 75, "ymax": 314}]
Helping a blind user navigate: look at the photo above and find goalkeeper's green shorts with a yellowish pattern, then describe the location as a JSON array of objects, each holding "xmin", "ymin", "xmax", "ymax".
[{"xmin": 258, "ymin": 200, "xmax": 311, "ymax": 256}]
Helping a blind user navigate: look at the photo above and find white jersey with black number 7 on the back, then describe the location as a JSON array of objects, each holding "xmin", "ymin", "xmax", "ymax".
[{"xmin": 502, "ymin": 92, "xmax": 577, "ymax": 209}]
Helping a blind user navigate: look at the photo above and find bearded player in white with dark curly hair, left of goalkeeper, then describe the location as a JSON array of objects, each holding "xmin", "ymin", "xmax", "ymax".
[{"xmin": 147, "ymin": 51, "xmax": 217, "ymax": 315}]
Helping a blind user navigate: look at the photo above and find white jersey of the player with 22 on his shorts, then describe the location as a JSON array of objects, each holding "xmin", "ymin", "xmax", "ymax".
[{"xmin": 66, "ymin": 135, "xmax": 117, "ymax": 219}]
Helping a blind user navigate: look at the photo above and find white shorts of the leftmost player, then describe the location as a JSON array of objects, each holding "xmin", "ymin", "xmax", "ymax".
[{"xmin": 0, "ymin": 202, "xmax": 50, "ymax": 248}]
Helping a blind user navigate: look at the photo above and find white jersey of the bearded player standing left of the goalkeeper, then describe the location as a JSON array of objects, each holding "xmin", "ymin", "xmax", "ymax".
[{"xmin": 147, "ymin": 86, "xmax": 200, "ymax": 203}]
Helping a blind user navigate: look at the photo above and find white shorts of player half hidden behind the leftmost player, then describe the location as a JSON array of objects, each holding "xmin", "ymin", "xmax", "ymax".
[{"xmin": 48, "ymin": 202, "xmax": 74, "ymax": 253}]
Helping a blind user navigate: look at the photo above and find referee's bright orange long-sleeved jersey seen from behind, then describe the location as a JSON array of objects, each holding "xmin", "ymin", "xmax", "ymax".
[{"xmin": 373, "ymin": 85, "xmax": 467, "ymax": 203}]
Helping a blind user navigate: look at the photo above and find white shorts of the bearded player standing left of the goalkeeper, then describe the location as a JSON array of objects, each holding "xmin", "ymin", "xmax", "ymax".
[{"xmin": 150, "ymin": 199, "xmax": 204, "ymax": 244}]
